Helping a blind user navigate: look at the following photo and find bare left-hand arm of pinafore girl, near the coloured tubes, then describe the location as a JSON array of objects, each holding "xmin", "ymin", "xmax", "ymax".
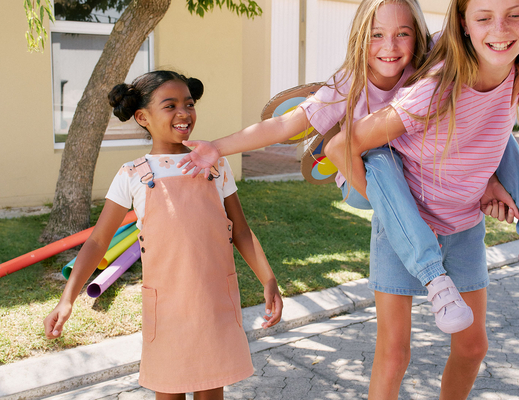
[{"xmin": 43, "ymin": 200, "xmax": 128, "ymax": 339}]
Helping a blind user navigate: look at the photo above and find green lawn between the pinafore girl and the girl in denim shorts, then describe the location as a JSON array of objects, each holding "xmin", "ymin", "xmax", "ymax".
[{"xmin": 235, "ymin": 182, "xmax": 371, "ymax": 306}]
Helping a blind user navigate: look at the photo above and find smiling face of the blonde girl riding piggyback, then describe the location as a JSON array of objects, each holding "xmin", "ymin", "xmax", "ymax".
[{"xmin": 368, "ymin": 3, "xmax": 416, "ymax": 90}]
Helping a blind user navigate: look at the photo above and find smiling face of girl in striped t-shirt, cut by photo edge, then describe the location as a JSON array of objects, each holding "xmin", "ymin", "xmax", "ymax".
[{"xmin": 461, "ymin": 0, "xmax": 519, "ymax": 84}]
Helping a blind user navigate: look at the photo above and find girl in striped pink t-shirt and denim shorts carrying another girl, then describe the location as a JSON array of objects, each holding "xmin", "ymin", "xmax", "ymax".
[{"xmin": 329, "ymin": 0, "xmax": 519, "ymax": 399}]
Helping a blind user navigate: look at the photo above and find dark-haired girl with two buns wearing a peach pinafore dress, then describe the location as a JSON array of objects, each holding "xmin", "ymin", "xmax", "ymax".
[{"xmin": 44, "ymin": 71, "xmax": 283, "ymax": 400}]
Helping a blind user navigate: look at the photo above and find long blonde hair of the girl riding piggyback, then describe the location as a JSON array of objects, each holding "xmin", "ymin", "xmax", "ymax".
[{"xmin": 329, "ymin": 0, "xmax": 431, "ymax": 189}]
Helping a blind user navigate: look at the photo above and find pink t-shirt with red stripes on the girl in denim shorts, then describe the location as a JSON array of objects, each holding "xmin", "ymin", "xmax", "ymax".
[{"xmin": 391, "ymin": 68, "xmax": 517, "ymax": 235}]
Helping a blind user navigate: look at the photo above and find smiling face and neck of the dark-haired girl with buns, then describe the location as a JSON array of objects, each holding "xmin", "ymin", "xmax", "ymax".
[{"xmin": 135, "ymin": 81, "xmax": 196, "ymax": 154}]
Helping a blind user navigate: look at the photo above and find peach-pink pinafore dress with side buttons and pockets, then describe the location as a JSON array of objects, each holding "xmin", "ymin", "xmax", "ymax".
[{"xmin": 134, "ymin": 158, "xmax": 254, "ymax": 393}]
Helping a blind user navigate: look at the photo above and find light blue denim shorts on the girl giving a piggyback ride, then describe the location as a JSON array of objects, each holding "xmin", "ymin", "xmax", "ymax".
[{"xmin": 369, "ymin": 214, "xmax": 489, "ymax": 296}]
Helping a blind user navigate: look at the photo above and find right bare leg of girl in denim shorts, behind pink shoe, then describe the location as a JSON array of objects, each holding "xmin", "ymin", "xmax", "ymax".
[{"xmin": 440, "ymin": 289, "xmax": 488, "ymax": 400}]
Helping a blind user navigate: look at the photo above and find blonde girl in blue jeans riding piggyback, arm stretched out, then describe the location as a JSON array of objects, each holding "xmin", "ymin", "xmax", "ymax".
[{"xmin": 179, "ymin": 0, "xmax": 519, "ymax": 333}]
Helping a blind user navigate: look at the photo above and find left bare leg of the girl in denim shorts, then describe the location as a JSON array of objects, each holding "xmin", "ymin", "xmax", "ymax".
[{"xmin": 368, "ymin": 291, "xmax": 413, "ymax": 400}]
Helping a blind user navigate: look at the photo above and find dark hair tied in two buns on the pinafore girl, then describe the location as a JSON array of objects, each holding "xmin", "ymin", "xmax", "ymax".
[{"xmin": 108, "ymin": 70, "xmax": 204, "ymax": 122}]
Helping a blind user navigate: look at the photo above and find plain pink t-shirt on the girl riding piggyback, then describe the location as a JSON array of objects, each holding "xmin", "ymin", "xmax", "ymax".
[{"xmin": 300, "ymin": 64, "xmax": 415, "ymax": 187}]
